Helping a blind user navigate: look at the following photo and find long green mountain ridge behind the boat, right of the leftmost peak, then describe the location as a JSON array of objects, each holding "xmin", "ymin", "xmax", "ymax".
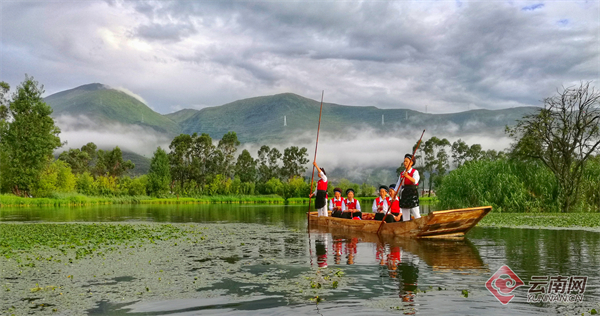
[{"xmin": 176, "ymin": 93, "xmax": 536, "ymax": 142}]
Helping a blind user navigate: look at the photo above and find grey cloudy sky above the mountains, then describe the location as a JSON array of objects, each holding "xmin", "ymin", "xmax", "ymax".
[{"xmin": 0, "ymin": 0, "xmax": 600, "ymax": 113}]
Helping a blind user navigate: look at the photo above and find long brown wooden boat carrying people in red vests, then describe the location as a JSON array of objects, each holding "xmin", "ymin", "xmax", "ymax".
[{"xmin": 308, "ymin": 206, "xmax": 492, "ymax": 238}]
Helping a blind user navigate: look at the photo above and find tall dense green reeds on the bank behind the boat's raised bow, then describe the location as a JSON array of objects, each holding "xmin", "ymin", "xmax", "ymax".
[{"xmin": 436, "ymin": 157, "xmax": 600, "ymax": 213}]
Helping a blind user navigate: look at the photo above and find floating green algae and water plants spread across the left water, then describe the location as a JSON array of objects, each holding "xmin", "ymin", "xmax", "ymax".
[{"xmin": 0, "ymin": 223, "xmax": 349, "ymax": 315}]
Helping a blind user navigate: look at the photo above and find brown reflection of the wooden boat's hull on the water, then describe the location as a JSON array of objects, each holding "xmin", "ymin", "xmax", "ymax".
[{"xmin": 310, "ymin": 226, "xmax": 488, "ymax": 271}]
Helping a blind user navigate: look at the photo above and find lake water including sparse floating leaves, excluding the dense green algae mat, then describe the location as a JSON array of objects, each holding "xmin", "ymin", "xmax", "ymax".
[{"xmin": 0, "ymin": 204, "xmax": 600, "ymax": 315}]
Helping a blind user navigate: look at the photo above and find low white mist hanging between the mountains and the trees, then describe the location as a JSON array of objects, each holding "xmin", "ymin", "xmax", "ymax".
[{"xmin": 56, "ymin": 116, "xmax": 511, "ymax": 184}]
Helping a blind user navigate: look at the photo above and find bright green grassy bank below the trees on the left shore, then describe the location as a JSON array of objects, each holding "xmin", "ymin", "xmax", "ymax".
[{"xmin": 0, "ymin": 194, "xmax": 285, "ymax": 207}]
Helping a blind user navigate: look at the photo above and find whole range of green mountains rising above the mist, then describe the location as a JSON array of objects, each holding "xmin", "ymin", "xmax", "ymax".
[{"xmin": 45, "ymin": 83, "xmax": 536, "ymax": 144}]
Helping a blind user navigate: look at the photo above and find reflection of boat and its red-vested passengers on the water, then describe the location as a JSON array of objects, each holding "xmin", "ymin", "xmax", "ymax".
[{"xmin": 309, "ymin": 226, "xmax": 487, "ymax": 315}]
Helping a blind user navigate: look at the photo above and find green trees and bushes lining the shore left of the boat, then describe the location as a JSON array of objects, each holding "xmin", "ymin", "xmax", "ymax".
[{"xmin": 0, "ymin": 75, "xmax": 346, "ymax": 197}]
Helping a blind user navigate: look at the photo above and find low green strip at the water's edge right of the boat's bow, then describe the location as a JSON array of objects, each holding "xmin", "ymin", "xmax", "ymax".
[{"xmin": 477, "ymin": 212, "xmax": 600, "ymax": 228}]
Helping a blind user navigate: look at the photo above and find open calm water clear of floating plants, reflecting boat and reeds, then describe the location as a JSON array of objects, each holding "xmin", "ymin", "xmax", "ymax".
[{"xmin": 0, "ymin": 205, "xmax": 600, "ymax": 315}]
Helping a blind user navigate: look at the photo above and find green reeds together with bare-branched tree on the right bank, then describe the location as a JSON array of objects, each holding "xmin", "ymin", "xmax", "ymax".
[{"xmin": 436, "ymin": 82, "xmax": 600, "ymax": 212}]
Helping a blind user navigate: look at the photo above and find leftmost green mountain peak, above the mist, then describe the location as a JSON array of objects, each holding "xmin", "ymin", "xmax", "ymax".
[{"xmin": 44, "ymin": 83, "xmax": 181, "ymax": 135}]
